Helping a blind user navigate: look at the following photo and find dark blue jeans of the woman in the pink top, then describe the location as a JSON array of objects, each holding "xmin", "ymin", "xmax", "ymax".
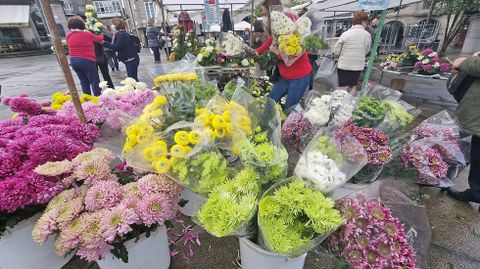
[{"xmin": 70, "ymin": 57, "xmax": 102, "ymax": 96}]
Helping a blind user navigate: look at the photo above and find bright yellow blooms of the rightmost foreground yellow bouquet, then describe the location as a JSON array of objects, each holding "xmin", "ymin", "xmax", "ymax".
[{"xmin": 195, "ymin": 102, "xmax": 252, "ymax": 140}]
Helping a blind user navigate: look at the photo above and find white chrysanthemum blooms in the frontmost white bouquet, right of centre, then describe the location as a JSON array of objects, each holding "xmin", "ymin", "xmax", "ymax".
[{"xmin": 295, "ymin": 150, "xmax": 347, "ymax": 193}]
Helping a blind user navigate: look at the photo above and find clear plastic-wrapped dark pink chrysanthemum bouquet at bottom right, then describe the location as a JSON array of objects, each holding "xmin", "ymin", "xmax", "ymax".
[{"xmin": 325, "ymin": 180, "xmax": 432, "ymax": 268}]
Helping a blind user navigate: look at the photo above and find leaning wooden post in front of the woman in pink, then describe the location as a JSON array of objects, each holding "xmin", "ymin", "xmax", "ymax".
[{"xmin": 40, "ymin": 0, "xmax": 87, "ymax": 123}]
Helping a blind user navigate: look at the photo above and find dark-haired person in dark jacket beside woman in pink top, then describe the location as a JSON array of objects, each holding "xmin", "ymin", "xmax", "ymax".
[{"xmin": 103, "ymin": 18, "xmax": 140, "ymax": 81}]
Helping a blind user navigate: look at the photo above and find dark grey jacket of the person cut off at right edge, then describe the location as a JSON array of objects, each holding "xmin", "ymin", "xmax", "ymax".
[{"xmin": 455, "ymin": 57, "xmax": 480, "ymax": 137}]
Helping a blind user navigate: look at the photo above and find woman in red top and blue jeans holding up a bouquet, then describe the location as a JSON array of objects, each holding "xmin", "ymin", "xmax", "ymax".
[{"xmin": 256, "ymin": 0, "xmax": 312, "ymax": 110}]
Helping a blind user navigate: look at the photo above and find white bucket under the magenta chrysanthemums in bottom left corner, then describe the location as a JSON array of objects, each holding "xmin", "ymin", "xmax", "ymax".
[{"xmin": 0, "ymin": 214, "xmax": 72, "ymax": 269}]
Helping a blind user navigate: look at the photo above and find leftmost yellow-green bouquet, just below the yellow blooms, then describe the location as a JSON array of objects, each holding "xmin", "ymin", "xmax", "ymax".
[{"xmin": 172, "ymin": 151, "xmax": 228, "ymax": 193}]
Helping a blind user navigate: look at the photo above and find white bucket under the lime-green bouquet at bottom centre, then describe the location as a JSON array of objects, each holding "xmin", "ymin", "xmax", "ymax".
[{"xmin": 239, "ymin": 238, "xmax": 307, "ymax": 269}]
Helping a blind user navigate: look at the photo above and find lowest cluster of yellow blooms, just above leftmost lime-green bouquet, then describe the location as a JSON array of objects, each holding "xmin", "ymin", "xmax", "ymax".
[{"xmin": 142, "ymin": 130, "xmax": 202, "ymax": 174}]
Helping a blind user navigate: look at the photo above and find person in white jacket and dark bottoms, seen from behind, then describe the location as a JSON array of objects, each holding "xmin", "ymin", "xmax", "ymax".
[{"xmin": 333, "ymin": 11, "xmax": 372, "ymax": 91}]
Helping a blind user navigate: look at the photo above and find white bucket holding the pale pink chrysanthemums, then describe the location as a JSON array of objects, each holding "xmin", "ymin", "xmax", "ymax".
[{"xmin": 97, "ymin": 225, "xmax": 170, "ymax": 269}]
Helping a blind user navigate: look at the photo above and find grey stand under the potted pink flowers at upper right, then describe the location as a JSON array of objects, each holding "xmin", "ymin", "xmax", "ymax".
[{"xmin": 372, "ymin": 69, "xmax": 457, "ymax": 107}]
